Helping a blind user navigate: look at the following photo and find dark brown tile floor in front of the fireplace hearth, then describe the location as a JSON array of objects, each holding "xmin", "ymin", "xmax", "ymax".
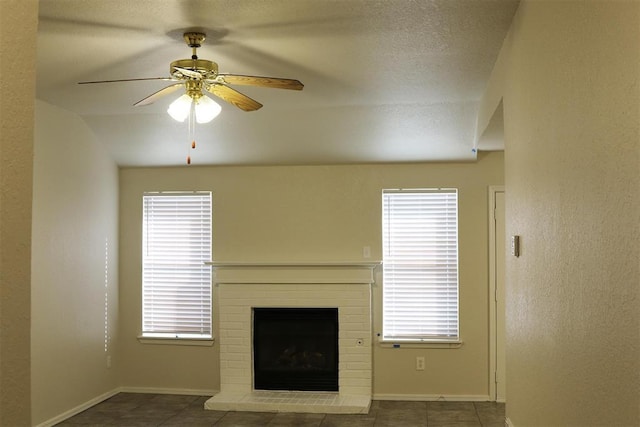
[{"xmin": 57, "ymin": 393, "xmax": 504, "ymax": 427}]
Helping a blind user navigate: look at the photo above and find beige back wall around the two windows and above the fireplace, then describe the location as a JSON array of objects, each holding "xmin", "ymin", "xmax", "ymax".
[{"xmin": 120, "ymin": 153, "xmax": 503, "ymax": 397}]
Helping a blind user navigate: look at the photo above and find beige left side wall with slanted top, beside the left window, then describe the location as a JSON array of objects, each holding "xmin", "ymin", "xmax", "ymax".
[{"xmin": 31, "ymin": 101, "xmax": 120, "ymax": 424}]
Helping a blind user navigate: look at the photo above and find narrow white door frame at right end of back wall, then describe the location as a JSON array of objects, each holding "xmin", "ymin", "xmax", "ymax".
[{"xmin": 489, "ymin": 185, "xmax": 506, "ymax": 401}]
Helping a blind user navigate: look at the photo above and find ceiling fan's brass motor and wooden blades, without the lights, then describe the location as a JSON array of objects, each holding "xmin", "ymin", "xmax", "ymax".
[{"xmin": 79, "ymin": 32, "xmax": 304, "ymax": 111}]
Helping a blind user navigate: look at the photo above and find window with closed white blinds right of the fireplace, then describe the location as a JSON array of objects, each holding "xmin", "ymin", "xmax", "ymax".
[{"xmin": 382, "ymin": 189, "xmax": 459, "ymax": 342}]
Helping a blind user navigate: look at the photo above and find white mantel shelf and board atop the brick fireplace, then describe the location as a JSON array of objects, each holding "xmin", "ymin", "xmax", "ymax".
[{"xmin": 206, "ymin": 262, "xmax": 381, "ymax": 284}]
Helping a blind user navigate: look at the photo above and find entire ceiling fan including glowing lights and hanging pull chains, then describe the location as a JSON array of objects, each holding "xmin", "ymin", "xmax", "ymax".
[{"xmin": 80, "ymin": 32, "xmax": 304, "ymax": 164}]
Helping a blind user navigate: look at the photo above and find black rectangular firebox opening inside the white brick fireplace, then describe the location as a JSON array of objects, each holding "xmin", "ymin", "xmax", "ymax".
[{"xmin": 253, "ymin": 308, "xmax": 338, "ymax": 391}]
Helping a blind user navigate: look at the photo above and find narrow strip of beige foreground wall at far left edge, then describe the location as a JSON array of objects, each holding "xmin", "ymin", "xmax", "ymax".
[{"xmin": 0, "ymin": 0, "xmax": 38, "ymax": 426}]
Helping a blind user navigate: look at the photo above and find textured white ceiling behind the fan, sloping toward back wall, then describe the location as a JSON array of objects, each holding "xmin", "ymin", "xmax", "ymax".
[{"xmin": 37, "ymin": 0, "xmax": 518, "ymax": 166}]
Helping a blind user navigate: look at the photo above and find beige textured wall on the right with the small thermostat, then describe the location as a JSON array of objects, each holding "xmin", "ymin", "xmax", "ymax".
[{"xmin": 503, "ymin": 1, "xmax": 640, "ymax": 427}]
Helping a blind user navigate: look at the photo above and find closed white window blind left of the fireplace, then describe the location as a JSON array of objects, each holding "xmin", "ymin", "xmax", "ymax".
[{"xmin": 142, "ymin": 192, "xmax": 211, "ymax": 338}]
